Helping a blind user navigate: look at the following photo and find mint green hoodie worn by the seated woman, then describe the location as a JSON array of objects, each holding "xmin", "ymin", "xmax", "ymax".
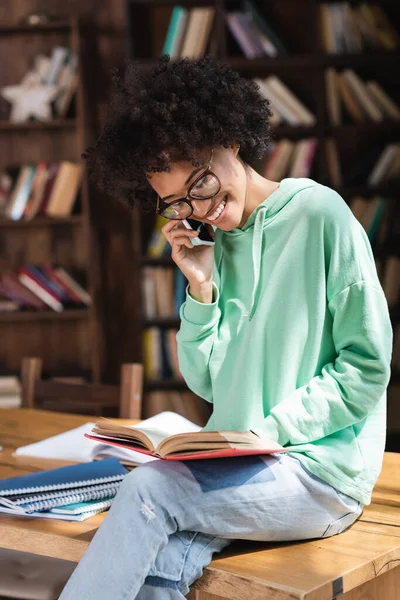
[{"xmin": 177, "ymin": 178, "xmax": 392, "ymax": 504}]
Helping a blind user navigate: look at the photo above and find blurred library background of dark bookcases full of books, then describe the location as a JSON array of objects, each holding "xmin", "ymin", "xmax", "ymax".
[{"xmin": 0, "ymin": 0, "xmax": 400, "ymax": 451}]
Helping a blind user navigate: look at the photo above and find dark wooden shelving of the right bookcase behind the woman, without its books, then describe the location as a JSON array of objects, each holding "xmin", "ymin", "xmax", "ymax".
[{"xmin": 125, "ymin": 0, "xmax": 400, "ymax": 432}]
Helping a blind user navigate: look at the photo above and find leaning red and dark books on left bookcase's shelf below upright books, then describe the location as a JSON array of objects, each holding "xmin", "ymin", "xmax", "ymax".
[{"xmin": 0, "ymin": 265, "xmax": 92, "ymax": 312}]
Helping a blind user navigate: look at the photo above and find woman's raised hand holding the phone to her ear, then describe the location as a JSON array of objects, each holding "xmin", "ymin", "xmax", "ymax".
[{"xmin": 161, "ymin": 219, "xmax": 214, "ymax": 289}]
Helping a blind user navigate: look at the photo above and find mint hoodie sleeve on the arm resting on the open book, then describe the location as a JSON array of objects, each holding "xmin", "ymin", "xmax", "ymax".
[{"xmin": 253, "ymin": 190, "xmax": 393, "ymax": 445}]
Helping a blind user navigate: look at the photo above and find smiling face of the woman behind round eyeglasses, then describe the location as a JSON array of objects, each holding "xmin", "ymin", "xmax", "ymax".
[{"xmin": 149, "ymin": 147, "xmax": 247, "ymax": 231}]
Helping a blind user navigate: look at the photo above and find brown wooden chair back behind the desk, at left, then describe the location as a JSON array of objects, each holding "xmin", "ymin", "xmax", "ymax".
[{"xmin": 21, "ymin": 358, "xmax": 143, "ymax": 419}]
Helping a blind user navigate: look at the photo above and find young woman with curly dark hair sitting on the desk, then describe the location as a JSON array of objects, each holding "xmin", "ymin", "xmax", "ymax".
[{"xmin": 61, "ymin": 57, "xmax": 392, "ymax": 600}]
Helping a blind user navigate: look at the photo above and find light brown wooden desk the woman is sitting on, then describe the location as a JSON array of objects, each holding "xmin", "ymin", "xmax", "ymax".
[{"xmin": 0, "ymin": 409, "xmax": 400, "ymax": 600}]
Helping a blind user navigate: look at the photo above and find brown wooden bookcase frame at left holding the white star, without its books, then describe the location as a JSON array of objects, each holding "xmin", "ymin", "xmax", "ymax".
[{"xmin": 0, "ymin": 19, "xmax": 102, "ymax": 382}]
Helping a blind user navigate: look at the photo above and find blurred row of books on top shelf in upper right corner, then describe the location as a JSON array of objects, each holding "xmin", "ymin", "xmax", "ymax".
[{"xmin": 320, "ymin": 2, "xmax": 400, "ymax": 54}]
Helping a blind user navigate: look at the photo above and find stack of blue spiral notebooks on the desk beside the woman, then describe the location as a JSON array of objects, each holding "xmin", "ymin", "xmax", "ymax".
[{"xmin": 0, "ymin": 458, "xmax": 129, "ymax": 521}]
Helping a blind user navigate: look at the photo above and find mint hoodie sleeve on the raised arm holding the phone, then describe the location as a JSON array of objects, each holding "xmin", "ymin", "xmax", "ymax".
[{"xmin": 176, "ymin": 283, "xmax": 221, "ymax": 402}]
